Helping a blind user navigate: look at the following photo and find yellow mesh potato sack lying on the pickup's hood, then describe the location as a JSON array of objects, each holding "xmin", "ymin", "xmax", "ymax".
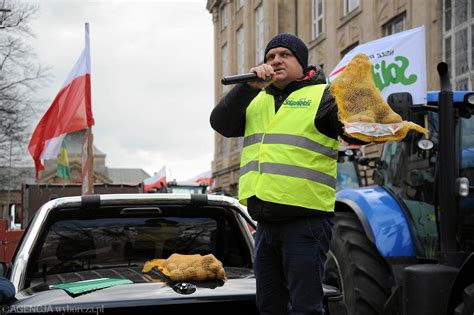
[{"xmin": 142, "ymin": 254, "xmax": 227, "ymax": 281}]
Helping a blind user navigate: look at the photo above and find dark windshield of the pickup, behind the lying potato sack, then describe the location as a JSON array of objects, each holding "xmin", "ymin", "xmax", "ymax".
[{"xmin": 27, "ymin": 209, "xmax": 251, "ymax": 278}]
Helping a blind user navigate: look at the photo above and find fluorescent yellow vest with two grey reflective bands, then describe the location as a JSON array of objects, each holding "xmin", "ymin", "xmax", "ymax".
[{"xmin": 239, "ymin": 84, "xmax": 339, "ymax": 211}]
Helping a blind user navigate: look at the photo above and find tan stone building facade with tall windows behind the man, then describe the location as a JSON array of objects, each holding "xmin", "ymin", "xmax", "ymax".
[{"xmin": 207, "ymin": 0, "xmax": 474, "ymax": 196}]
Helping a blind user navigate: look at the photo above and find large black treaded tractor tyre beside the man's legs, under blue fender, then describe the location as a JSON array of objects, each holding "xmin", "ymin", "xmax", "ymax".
[{"xmin": 324, "ymin": 212, "xmax": 393, "ymax": 315}]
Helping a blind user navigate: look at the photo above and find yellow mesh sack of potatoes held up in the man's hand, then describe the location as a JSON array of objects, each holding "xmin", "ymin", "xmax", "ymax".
[{"xmin": 331, "ymin": 54, "xmax": 428, "ymax": 142}]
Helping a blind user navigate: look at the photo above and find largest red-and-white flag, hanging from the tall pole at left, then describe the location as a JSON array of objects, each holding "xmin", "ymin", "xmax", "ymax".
[{"xmin": 28, "ymin": 23, "xmax": 94, "ymax": 179}]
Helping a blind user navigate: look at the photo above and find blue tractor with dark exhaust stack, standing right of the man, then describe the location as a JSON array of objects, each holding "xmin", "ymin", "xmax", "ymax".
[{"xmin": 324, "ymin": 63, "xmax": 474, "ymax": 315}]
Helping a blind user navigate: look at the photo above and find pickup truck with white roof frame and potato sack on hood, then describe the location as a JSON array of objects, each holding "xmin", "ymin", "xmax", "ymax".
[{"xmin": 1, "ymin": 193, "xmax": 342, "ymax": 315}]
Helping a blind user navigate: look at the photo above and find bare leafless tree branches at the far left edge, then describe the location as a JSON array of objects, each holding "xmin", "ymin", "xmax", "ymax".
[{"xmin": 0, "ymin": 0, "xmax": 49, "ymax": 185}]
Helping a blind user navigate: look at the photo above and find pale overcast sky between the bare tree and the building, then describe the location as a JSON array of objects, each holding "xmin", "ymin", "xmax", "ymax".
[{"xmin": 31, "ymin": 0, "xmax": 214, "ymax": 180}]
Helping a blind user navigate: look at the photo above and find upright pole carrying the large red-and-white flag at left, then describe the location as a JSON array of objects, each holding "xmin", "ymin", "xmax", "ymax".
[{"xmin": 82, "ymin": 23, "xmax": 94, "ymax": 195}]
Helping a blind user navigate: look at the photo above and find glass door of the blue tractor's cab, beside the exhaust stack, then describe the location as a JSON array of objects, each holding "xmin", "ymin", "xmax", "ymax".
[{"xmin": 379, "ymin": 113, "xmax": 438, "ymax": 258}]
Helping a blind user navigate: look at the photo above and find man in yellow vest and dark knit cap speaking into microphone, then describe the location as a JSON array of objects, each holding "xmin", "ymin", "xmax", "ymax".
[{"xmin": 210, "ymin": 33, "xmax": 360, "ymax": 315}]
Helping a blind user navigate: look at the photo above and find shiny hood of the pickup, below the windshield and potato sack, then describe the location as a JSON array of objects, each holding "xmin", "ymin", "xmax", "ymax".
[{"xmin": 11, "ymin": 268, "xmax": 256, "ymax": 311}]
